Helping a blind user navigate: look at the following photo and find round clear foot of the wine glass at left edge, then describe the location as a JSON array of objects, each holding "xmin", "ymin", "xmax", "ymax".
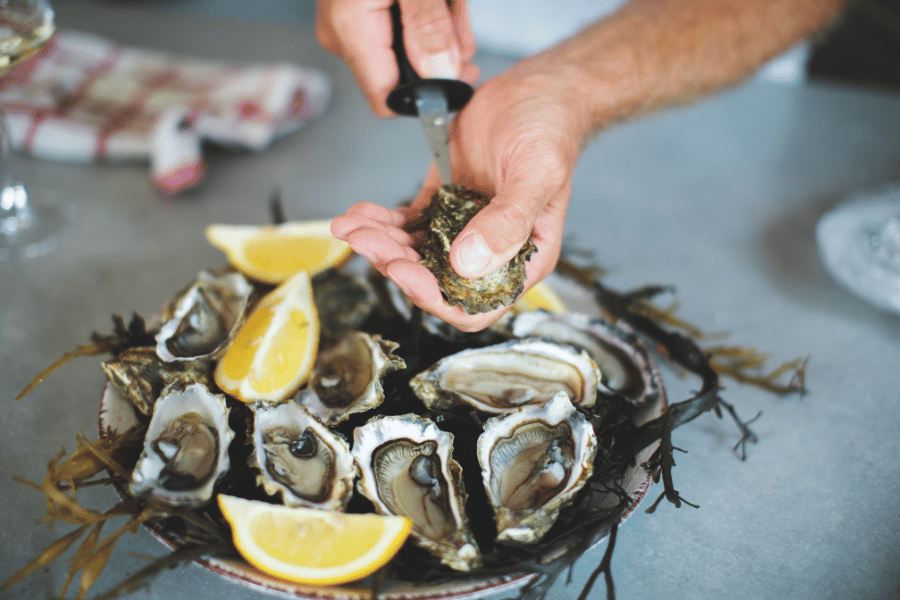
[{"xmin": 0, "ymin": 200, "xmax": 77, "ymax": 260}]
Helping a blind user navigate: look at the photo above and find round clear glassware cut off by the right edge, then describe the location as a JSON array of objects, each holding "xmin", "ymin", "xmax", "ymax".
[{"xmin": 816, "ymin": 184, "xmax": 900, "ymax": 313}]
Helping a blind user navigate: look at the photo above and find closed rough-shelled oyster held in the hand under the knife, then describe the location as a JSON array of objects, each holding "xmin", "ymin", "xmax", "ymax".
[{"xmin": 420, "ymin": 184, "xmax": 537, "ymax": 315}]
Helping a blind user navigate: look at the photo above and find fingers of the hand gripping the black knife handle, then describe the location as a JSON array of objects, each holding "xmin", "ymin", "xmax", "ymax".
[{"xmin": 316, "ymin": 0, "xmax": 478, "ymax": 117}]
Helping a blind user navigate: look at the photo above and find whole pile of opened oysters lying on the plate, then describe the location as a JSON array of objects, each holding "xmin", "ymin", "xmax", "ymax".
[{"xmin": 104, "ymin": 250, "xmax": 663, "ymax": 572}]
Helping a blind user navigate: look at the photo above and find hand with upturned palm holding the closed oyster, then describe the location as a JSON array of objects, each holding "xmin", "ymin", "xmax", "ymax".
[{"xmin": 331, "ymin": 53, "xmax": 591, "ymax": 331}]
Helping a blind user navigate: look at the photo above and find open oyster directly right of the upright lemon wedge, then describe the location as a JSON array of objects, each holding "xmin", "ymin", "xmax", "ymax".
[{"xmin": 297, "ymin": 330, "xmax": 406, "ymax": 426}]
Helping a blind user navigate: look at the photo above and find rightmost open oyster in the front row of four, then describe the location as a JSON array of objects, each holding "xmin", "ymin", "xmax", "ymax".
[{"xmin": 478, "ymin": 392, "xmax": 597, "ymax": 544}]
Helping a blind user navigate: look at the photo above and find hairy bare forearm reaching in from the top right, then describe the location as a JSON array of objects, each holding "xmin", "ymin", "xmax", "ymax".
[{"xmin": 548, "ymin": 0, "xmax": 846, "ymax": 137}]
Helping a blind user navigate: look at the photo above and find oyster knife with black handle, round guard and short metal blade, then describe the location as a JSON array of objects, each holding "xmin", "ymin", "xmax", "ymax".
[{"xmin": 387, "ymin": 2, "xmax": 474, "ymax": 185}]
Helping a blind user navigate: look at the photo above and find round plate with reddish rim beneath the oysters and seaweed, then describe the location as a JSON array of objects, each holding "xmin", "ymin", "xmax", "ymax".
[{"xmin": 99, "ymin": 344, "xmax": 666, "ymax": 600}]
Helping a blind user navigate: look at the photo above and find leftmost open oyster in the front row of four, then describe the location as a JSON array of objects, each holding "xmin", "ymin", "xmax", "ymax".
[{"xmin": 130, "ymin": 382, "xmax": 234, "ymax": 506}]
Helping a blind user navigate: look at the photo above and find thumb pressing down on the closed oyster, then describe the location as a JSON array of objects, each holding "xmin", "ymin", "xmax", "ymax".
[{"xmin": 450, "ymin": 190, "xmax": 537, "ymax": 279}]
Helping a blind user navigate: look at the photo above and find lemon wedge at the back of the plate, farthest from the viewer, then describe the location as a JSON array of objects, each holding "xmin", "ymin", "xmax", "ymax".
[{"xmin": 206, "ymin": 221, "xmax": 351, "ymax": 284}]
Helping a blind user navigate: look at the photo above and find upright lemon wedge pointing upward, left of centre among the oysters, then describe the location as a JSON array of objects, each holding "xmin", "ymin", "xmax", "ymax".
[{"xmin": 215, "ymin": 271, "xmax": 319, "ymax": 402}]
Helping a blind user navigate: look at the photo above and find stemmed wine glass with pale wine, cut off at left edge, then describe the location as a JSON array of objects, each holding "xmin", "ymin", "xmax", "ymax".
[{"xmin": 0, "ymin": 0, "xmax": 74, "ymax": 260}]
